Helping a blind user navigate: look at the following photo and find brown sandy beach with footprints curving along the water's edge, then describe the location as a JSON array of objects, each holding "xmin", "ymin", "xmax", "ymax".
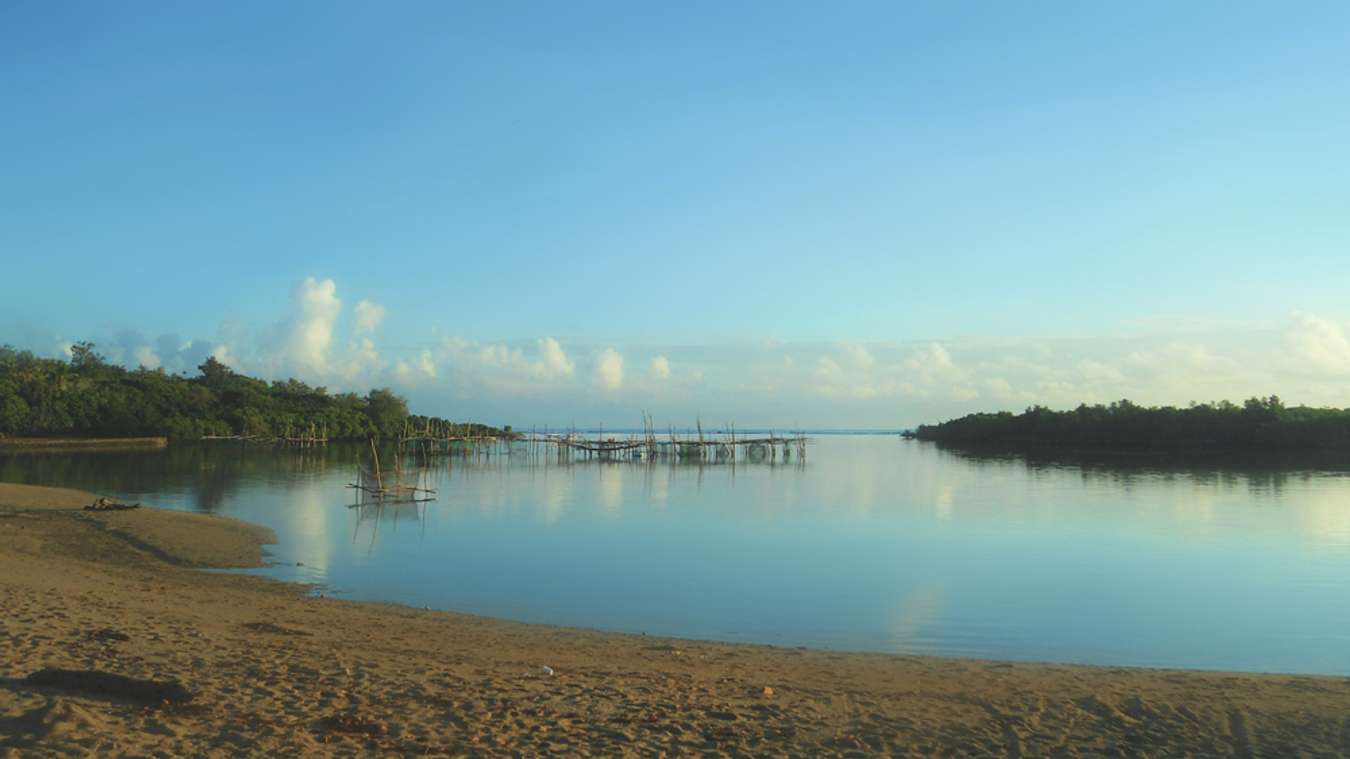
[{"xmin": 0, "ymin": 485, "xmax": 1350, "ymax": 756}]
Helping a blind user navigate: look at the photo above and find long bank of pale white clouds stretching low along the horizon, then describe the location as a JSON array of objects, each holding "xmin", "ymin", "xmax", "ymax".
[{"xmin": 30, "ymin": 277, "xmax": 1350, "ymax": 427}]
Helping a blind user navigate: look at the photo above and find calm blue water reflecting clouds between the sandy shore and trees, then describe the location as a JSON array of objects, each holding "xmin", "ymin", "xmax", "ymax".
[{"xmin": 0, "ymin": 435, "xmax": 1350, "ymax": 674}]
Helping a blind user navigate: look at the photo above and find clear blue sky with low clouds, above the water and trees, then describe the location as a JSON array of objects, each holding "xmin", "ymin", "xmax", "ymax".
[{"xmin": 0, "ymin": 1, "xmax": 1350, "ymax": 427}]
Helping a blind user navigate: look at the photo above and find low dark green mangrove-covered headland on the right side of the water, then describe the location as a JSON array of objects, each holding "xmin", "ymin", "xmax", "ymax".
[{"xmin": 917, "ymin": 396, "xmax": 1350, "ymax": 450}]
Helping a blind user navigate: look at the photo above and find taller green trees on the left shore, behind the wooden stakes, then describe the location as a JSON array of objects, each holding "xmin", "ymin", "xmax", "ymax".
[{"xmin": 0, "ymin": 343, "xmax": 481, "ymax": 439}]
